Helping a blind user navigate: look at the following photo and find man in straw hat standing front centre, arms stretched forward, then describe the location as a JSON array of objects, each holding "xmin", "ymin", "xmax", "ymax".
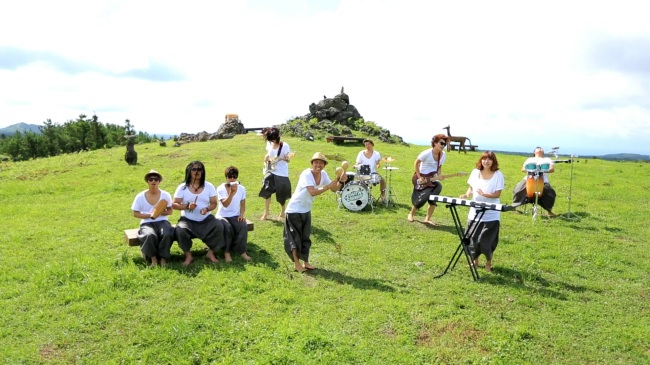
[{"xmin": 284, "ymin": 152, "xmax": 347, "ymax": 272}]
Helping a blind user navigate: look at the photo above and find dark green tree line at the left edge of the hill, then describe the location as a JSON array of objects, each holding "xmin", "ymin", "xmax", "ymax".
[{"xmin": 0, "ymin": 114, "xmax": 165, "ymax": 161}]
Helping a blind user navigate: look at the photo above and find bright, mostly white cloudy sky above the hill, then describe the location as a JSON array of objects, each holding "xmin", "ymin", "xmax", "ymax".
[{"xmin": 0, "ymin": 0, "xmax": 650, "ymax": 155}]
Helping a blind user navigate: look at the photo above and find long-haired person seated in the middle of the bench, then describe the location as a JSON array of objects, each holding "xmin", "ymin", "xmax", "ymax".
[{"xmin": 172, "ymin": 161, "xmax": 226, "ymax": 266}]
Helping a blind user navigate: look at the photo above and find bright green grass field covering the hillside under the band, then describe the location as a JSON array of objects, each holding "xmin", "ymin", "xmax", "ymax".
[{"xmin": 0, "ymin": 134, "xmax": 650, "ymax": 364}]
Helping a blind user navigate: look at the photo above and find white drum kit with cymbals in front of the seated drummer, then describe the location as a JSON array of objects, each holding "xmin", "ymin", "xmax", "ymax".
[{"xmin": 338, "ymin": 157, "xmax": 398, "ymax": 212}]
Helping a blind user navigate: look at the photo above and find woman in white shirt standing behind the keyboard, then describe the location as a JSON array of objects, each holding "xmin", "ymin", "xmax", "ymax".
[{"xmin": 460, "ymin": 151, "xmax": 505, "ymax": 271}]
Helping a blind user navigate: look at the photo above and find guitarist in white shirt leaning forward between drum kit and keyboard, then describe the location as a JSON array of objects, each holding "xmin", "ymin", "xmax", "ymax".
[{"xmin": 407, "ymin": 134, "xmax": 449, "ymax": 225}]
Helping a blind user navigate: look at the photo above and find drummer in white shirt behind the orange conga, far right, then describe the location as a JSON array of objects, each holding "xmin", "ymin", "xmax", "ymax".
[{"xmin": 512, "ymin": 147, "xmax": 556, "ymax": 217}]
